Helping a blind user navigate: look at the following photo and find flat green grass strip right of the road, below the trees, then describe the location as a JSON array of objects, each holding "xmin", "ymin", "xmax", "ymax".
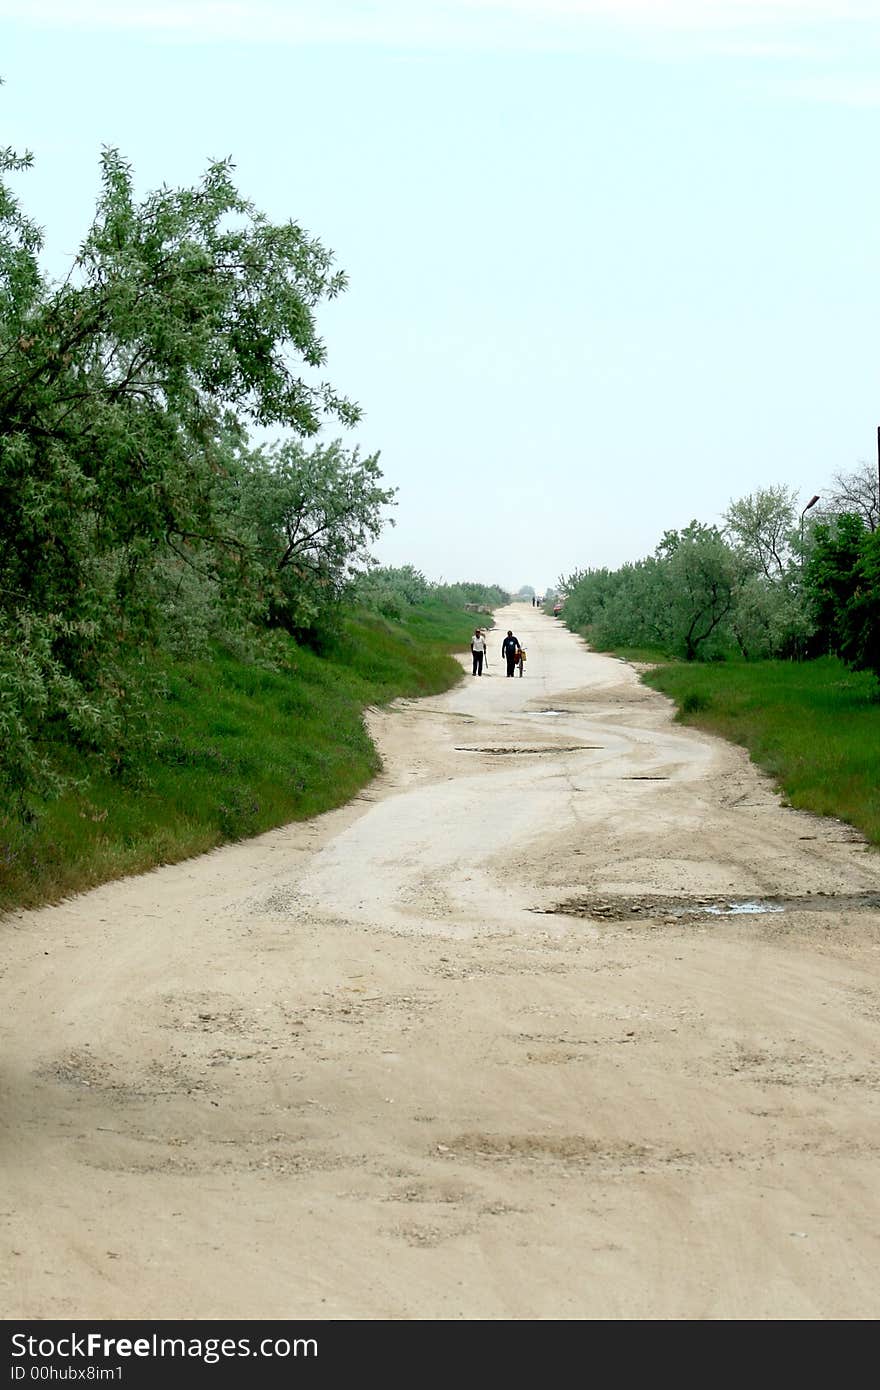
[{"xmin": 642, "ymin": 657, "xmax": 880, "ymax": 845}]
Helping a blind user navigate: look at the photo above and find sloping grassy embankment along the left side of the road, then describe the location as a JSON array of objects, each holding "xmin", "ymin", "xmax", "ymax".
[{"xmin": 0, "ymin": 605, "xmax": 491, "ymax": 910}]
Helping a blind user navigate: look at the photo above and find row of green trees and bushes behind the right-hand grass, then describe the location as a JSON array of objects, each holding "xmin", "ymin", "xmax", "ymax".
[{"xmin": 560, "ymin": 464, "xmax": 880, "ymax": 674}]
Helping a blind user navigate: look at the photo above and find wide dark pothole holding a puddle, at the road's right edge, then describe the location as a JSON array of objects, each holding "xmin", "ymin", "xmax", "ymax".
[{"xmin": 535, "ymin": 892, "xmax": 880, "ymax": 922}]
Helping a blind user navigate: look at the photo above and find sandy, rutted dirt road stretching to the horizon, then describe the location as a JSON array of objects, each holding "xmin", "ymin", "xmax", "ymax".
[{"xmin": 0, "ymin": 607, "xmax": 880, "ymax": 1319}]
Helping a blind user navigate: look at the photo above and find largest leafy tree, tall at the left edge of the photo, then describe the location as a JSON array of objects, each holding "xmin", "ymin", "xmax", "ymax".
[{"xmin": 0, "ymin": 150, "xmax": 357, "ymax": 806}]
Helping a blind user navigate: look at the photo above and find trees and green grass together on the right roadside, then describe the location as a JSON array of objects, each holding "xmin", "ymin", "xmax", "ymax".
[{"xmin": 560, "ymin": 464, "xmax": 880, "ymax": 845}]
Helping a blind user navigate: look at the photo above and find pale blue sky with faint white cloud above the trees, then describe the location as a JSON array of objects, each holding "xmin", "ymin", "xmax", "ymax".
[{"xmin": 0, "ymin": 0, "xmax": 880, "ymax": 588}]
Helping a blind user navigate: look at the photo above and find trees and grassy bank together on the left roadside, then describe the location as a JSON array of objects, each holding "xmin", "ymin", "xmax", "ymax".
[{"xmin": 0, "ymin": 127, "xmax": 506, "ymax": 908}]
